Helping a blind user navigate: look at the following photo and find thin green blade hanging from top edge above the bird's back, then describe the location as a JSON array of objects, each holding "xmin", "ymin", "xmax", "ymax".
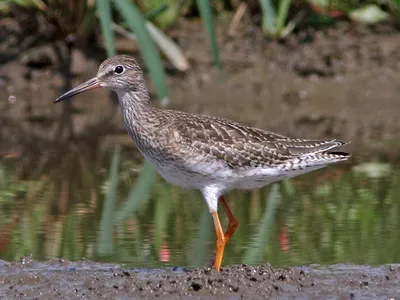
[{"xmin": 196, "ymin": 0, "xmax": 222, "ymax": 72}]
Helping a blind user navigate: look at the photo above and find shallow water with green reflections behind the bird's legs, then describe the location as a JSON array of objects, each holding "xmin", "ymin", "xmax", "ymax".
[{"xmin": 0, "ymin": 145, "xmax": 400, "ymax": 268}]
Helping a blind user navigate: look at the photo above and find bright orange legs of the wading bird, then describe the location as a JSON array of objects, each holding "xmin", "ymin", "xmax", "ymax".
[{"xmin": 212, "ymin": 196, "xmax": 239, "ymax": 272}]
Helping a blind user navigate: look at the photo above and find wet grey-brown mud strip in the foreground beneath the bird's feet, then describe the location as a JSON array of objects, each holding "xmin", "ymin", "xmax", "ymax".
[{"xmin": 0, "ymin": 257, "xmax": 400, "ymax": 299}]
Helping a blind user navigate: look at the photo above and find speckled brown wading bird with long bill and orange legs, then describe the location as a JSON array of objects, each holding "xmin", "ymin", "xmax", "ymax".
[{"xmin": 54, "ymin": 55, "xmax": 351, "ymax": 272}]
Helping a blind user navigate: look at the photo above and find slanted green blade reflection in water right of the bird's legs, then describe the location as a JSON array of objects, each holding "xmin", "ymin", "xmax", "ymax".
[{"xmin": 243, "ymin": 184, "xmax": 280, "ymax": 265}]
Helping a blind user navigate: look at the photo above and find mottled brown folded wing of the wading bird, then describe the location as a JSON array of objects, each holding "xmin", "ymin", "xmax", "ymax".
[{"xmin": 175, "ymin": 115, "xmax": 344, "ymax": 168}]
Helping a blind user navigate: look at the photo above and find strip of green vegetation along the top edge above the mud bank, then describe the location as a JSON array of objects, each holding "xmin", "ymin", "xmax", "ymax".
[{"xmin": 0, "ymin": 0, "xmax": 400, "ymax": 42}]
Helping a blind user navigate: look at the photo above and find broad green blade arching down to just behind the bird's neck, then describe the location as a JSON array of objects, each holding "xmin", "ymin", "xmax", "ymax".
[{"xmin": 114, "ymin": 0, "xmax": 168, "ymax": 103}]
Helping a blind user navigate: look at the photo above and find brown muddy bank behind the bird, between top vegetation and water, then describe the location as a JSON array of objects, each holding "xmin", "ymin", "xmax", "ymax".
[{"xmin": 0, "ymin": 22, "xmax": 400, "ymax": 155}]
